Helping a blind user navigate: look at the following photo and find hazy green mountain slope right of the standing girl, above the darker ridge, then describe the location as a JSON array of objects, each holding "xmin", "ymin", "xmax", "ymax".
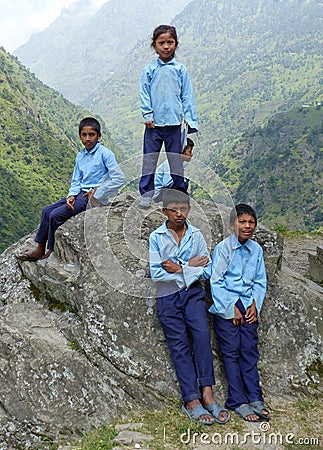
[{"xmin": 174, "ymin": 0, "xmax": 323, "ymax": 141}]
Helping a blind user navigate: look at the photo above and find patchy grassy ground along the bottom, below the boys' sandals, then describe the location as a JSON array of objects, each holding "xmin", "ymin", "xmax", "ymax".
[{"xmin": 62, "ymin": 397, "xmax": 323, "ymax": 450}]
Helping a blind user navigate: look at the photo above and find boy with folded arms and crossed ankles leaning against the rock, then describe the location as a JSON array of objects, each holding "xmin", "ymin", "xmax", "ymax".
[{"xmin": 149, "ymin": 189, "xmax": 230, "ymax": 425}]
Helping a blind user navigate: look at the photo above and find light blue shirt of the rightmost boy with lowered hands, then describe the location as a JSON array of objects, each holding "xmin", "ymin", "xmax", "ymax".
[{"xmin": 209, "ymin": 234, "xmax": 266, "ymax": 319}]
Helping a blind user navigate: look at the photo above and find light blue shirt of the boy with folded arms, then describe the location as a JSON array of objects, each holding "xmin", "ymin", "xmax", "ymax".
[{"xmin": 149, "ymin": 221, "xmax": 211, "ymax": 289}]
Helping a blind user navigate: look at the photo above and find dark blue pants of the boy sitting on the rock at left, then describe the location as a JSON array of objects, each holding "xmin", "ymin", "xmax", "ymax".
[{"xmin": 35, "ymin": 192, "xmax": 87, "ymax": 250}]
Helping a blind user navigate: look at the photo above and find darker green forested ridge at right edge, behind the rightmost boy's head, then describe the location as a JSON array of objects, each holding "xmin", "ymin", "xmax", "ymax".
[{"xmin": 232, "ymin": 105, "xmax": 323, "ymax": 230}]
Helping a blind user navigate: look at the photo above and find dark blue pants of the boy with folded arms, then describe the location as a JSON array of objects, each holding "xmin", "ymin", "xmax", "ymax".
[{"xmin": 156, "ymin": 285, "xmax": 215, "ymax": 403}]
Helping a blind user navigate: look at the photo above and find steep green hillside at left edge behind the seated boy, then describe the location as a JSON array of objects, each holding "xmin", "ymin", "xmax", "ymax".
[{"xmin": 0, "ymin": 49, "xmax": 116, "ymax": 251}]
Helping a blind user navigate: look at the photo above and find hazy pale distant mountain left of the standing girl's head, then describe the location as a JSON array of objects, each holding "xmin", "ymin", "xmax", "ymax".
[{"xmin": 14, "ymin": 0, "xmax": 191, "ymax": 106}]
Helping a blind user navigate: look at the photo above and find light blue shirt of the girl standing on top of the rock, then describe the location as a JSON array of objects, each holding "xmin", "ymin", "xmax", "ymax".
[{"xmin": 140, "ymin": 58, "xmax": 198, "ymax": 131}]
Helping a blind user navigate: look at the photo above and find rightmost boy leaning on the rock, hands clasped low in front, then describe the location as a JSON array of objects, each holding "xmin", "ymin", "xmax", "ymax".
[{"xmin": 209, "ymin": 204, "xmax": 270, "ymax": 422}]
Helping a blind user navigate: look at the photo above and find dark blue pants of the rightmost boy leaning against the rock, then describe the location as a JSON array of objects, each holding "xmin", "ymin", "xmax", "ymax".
[{"xmin": 214, "ymin": 300, "xmax": 263, "ymax": 409}]
